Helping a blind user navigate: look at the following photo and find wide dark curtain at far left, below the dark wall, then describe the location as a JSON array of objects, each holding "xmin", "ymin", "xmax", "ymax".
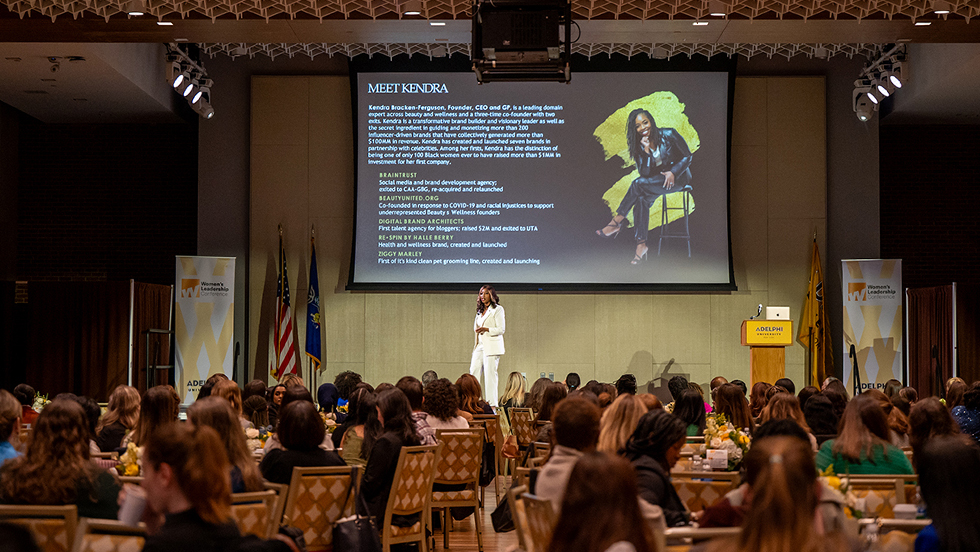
[{"xmin": 27, "ymin": 282, "xmax": 129, "ymax": 402}]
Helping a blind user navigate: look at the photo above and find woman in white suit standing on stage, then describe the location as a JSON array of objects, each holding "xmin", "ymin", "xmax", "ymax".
[{"xmin": 470, "ymin": 285, "xmax": 506, "ymax": 407}]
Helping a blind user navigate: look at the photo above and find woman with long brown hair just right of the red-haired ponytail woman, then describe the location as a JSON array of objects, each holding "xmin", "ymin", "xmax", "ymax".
[{"xmin": 187, "ymin": 395, "xmax": 263, "ymax": 493}]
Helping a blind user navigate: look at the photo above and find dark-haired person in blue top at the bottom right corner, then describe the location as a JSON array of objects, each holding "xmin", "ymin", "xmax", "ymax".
[{"xmin": 915, "ymin": 435, "xmax": 980, "ymax": 552}]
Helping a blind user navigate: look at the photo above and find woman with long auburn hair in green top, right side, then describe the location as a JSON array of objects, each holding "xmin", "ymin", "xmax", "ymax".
[{"xmin": 817, "ymin": 395, "xmax": 914, "ymax": 474}]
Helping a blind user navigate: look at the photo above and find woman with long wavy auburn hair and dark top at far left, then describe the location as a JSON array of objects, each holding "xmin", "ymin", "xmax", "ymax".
[{"xmin": 0, "ymin": 399, "xmax": 119, "ymax": 519}]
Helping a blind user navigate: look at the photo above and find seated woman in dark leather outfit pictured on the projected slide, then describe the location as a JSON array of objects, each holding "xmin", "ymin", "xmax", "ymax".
[{"xmin": 596, "ymin": 109, "xmax": 692, "ymax": 265}]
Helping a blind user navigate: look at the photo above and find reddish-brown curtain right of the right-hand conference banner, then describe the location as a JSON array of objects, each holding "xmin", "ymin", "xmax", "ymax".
[{"xmin": 908, "ymin": 286, "xmax": 953, "ymax": 397}]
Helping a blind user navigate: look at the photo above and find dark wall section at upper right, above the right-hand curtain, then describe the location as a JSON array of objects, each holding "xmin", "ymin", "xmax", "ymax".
[{"xmin": 879, "ymin": 125, "xmax": 980, "ymax": 288}]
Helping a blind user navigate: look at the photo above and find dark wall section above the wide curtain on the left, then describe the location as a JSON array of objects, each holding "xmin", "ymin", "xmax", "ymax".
[{"xmin": 17, "ymin": 121, "xmax": 198, "ymax": 284}]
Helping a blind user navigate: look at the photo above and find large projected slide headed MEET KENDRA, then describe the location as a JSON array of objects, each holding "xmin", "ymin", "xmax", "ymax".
[{"xmin": 348, "ymin": 72, "xmax": 734, "ymax": 290}]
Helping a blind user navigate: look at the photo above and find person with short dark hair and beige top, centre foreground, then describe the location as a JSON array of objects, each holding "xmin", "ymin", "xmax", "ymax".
[{"xmin": 535, "ymin": 394, "xmax": 600, "ymax": 513}]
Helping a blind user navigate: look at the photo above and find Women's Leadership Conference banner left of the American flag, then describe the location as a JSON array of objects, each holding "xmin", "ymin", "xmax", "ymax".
[{"xmin": 174, "ymin": 257, "xmax": 235, "ymax": 404}]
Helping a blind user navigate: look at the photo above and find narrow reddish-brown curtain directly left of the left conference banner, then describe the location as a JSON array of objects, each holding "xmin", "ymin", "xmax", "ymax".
[{"xmin": 133, "ymin": 282, "xmax": 173, "ymax": 393}]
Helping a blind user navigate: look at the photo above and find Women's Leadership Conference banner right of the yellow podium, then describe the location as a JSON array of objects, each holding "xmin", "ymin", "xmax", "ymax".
[{"xmin": 841, "ymin": 259, "xmax": 904, "ymax": 392}]
